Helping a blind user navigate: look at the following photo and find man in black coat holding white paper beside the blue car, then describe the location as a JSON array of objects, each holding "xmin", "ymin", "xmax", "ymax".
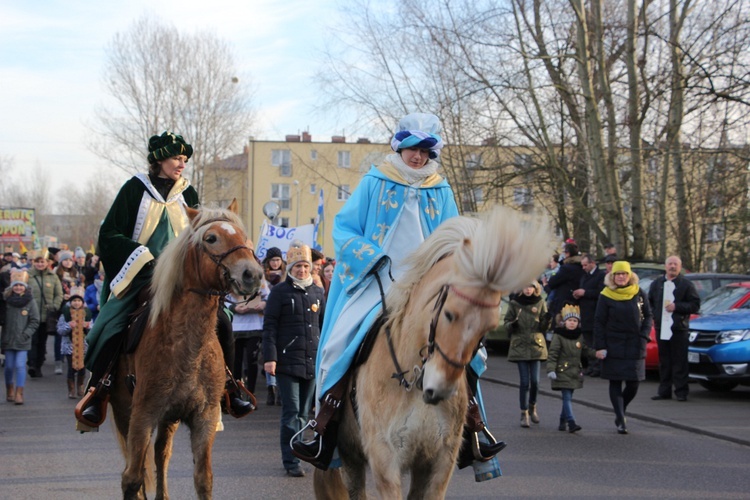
[{"xmin": 648, "ymin": 255, "xmax": 701, "ymax": 401}]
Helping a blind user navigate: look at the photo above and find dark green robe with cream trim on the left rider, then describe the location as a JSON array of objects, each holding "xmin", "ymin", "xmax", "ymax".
[{"xmin": 85, "ymin": 174, "xmax": 198, "ymax": 375}]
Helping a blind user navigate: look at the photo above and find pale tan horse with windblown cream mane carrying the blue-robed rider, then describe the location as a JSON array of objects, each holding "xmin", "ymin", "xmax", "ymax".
[{"xmin": 314, "ymin": 208, "xmax": 551, "ymax": 499}]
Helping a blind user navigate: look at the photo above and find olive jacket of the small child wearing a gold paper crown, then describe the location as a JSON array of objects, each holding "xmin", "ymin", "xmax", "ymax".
[{"xmin": 547, "ymin": 326, "xmax": 596, "ymax": 391}]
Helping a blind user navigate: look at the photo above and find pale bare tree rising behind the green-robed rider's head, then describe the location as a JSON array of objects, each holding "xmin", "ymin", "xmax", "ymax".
[{"xmin": 92, "ymin": 16, "xmax": 254, "ymax": 198}]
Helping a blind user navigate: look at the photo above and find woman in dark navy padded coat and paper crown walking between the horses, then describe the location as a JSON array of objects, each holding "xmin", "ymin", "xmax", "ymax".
[{"xmin": 263, "ymin": 240, "xmax": 326, "ymax": 477}]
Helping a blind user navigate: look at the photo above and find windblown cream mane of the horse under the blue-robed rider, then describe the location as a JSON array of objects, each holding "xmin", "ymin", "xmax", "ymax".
[{"xmin": 386, "ymin": 206, "xmax": 552, "ymax": 313}]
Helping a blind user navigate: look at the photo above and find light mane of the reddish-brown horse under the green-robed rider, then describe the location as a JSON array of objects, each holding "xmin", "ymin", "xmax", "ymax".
[{"xmin": 149, "ymin": 207, "xmax": 243, "ymax": 327}]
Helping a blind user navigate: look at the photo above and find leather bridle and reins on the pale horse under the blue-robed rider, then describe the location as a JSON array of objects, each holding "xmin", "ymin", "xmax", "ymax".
[{"xmin": 375, "ymin": 273, "xmax": 500, "ymax": 391}]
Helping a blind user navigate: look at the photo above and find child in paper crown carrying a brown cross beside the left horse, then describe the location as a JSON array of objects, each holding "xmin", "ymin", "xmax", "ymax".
[{"xmin": 57, "ymin": 286, "xmax": 91, "ymax": 399}]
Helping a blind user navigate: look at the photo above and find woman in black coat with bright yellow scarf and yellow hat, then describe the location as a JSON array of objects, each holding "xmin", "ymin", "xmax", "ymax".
[{"xmin": 594, "ymin": 261, "xmax": 653, "ymax": 434}]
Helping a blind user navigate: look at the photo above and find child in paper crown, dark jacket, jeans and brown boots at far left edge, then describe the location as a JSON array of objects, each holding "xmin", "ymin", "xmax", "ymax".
[{"xmin": 0, "ymin": 270, "xmax": 39, "ymax": 405}]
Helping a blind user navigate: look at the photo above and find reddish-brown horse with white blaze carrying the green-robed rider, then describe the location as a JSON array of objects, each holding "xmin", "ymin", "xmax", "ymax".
[{"xmin": 110, "ymin": 202, "xmax": 262, "ymax": 499}]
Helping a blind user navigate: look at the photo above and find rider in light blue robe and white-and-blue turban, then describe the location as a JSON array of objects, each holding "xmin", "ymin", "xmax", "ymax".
[{"xmin": 293, "ymin": 113, "xmax": 504, "ymax": 478}]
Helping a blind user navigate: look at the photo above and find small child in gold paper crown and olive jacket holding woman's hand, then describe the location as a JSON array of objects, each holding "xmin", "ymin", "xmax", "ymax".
[{"xmin": 547, "ymin": 304, "xmax": 596, "ymax": 432}]
